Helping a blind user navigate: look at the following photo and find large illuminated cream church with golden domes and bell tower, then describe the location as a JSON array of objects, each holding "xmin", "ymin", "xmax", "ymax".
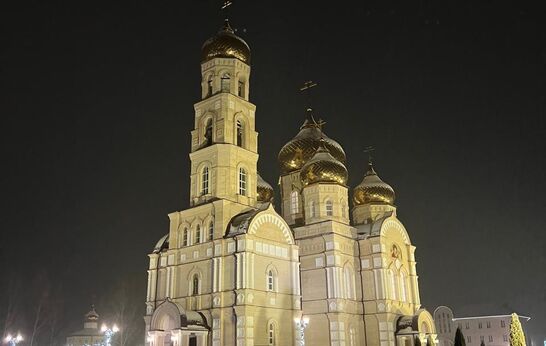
[{"xmin": 144, "ymin": 20, "xmax": 436, "ymax": 346}]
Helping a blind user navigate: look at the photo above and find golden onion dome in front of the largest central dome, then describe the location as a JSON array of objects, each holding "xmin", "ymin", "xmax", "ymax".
[{"xmin": 300, "ymin": 139, "xmax": 348, "ymax": 186}]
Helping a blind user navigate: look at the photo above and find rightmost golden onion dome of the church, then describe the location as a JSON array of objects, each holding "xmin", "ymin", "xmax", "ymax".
[{"xmin": 353, "ymin": 162, "xmax": 395, "ymax": 205}]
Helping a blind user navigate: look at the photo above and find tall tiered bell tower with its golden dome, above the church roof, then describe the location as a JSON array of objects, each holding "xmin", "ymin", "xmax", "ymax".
[{"xmin": 190, "ymin": 19, "xmax": 258, "ymax": 207}]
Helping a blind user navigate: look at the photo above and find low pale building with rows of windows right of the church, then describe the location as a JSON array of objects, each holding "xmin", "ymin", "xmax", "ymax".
[{"xmin": 434, "ymin": 306, "xmax": 530, "ymax": 346}]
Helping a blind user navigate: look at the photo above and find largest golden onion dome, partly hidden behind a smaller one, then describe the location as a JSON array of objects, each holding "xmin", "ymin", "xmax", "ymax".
[{"xmin": 278, "ymin": 108, "xmax": 346, "ymax": 174}]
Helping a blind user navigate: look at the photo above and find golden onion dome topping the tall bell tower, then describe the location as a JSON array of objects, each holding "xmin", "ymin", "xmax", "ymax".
[{"xmin": 201, "ymin": 19, "xmax": 250, "ymax": 65}]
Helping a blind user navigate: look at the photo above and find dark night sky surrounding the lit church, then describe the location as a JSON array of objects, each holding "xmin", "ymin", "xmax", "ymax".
[{"xmin": 0, "ymin": 0, "xmax": 546, "ymax": 342}]
